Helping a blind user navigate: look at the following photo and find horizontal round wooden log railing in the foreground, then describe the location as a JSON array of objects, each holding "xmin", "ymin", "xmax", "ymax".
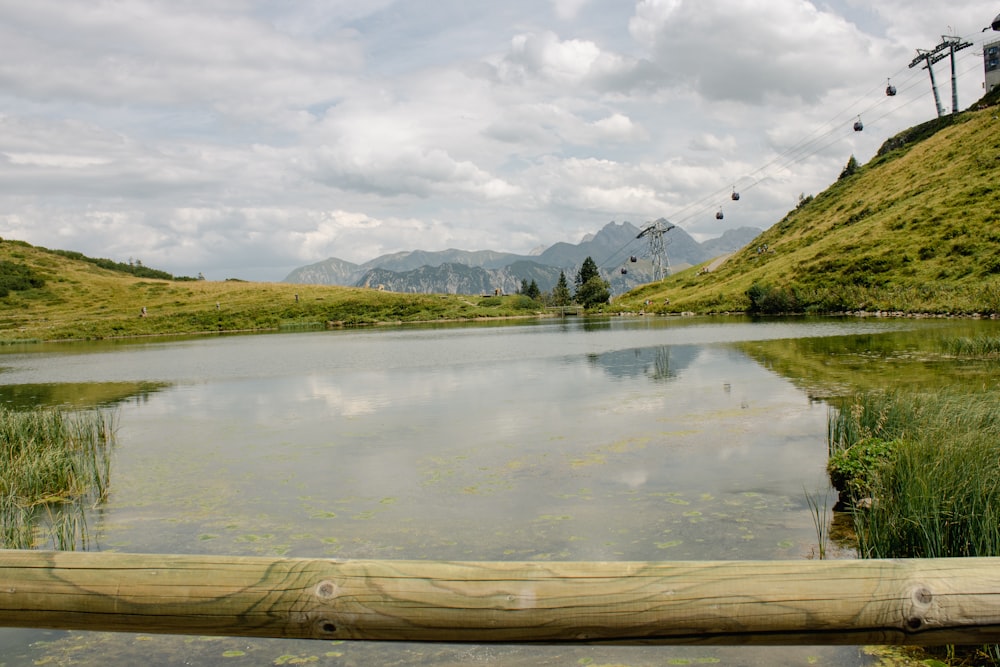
[{"xmin": 0, "ymin": 550, "xmax": 1000, "ymax": 645}]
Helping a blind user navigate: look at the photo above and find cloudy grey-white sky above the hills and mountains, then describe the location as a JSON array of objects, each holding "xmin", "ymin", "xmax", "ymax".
[{"xmin": 0, "ymin": 0, "xmax": 1000, "ymax": 281}]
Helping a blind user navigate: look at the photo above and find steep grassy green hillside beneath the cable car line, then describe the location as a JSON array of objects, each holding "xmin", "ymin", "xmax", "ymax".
[{"xmin": 615, "ymin": 102, "xmax": 1000, "ymax": 314}]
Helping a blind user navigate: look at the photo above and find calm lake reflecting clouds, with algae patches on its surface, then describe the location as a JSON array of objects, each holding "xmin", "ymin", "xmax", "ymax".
[{"xmin": 0, "ymin": 317, "xmax": 1000, "ymax": 667}]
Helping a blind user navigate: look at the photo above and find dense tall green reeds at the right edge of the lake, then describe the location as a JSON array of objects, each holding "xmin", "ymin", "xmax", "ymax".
[{"xmin": 829, "ymin": 391, "xmax": 1000, "ymax": 665}]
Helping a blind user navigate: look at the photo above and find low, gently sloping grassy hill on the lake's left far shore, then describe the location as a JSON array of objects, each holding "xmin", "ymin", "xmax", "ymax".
[{"xmin": 0, "ymin": 240, "xmax": 541, "ymax": 343}]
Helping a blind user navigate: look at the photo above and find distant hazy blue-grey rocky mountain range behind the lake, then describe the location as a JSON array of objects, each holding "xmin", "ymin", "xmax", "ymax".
[{"xmin": 284, "ymin": 221, "xmax": 762, "ymax": 294}]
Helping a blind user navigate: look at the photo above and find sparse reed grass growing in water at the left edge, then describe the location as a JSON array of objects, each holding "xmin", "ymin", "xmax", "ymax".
[{"xmin": 0, "ymin": 408, "xmax": 115, "ymax": 549}]
